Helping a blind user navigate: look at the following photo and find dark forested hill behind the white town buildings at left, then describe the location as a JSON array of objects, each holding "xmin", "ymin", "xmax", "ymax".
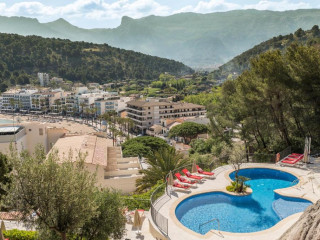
[{"xmin": 0, "ymin": 34, "xmax": 193, "ymax": 89}]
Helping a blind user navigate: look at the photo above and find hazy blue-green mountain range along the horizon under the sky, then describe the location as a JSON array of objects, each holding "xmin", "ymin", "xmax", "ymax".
[{"xmin": 0, "ymin": 9, "xmax": 320, "ymax": 68}]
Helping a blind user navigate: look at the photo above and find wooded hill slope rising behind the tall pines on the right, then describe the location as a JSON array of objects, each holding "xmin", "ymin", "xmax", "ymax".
[{"xmin": 210, "ymin": 25, "xmax": 320, "ymax": 80}]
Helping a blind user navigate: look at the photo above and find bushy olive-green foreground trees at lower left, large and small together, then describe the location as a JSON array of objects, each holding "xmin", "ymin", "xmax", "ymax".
[{"xmin": 5, "ymin": 147, "xmax": 125, "ymax": 240}]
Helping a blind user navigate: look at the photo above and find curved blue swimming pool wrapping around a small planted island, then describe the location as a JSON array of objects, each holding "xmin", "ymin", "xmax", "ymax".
[{"xmin": 175, "ymin": 168, "xmax": 312, "ymax": 234}]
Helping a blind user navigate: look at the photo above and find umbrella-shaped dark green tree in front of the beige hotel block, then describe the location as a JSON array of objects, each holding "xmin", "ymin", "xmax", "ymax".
[{"xmin": 169, "ymin": 122, "xmax": 208, "ymax": 143}]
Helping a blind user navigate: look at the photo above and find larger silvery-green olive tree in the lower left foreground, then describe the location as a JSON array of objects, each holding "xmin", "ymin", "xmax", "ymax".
[{"xmin": 6, "ymin": 147, "xmax": 96, "ymax": 240}]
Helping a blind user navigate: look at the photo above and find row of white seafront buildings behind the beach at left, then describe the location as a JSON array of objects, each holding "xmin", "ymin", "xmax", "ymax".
[{"xmin": 0, "ymin": 86, "xmax": 122, "ymax": 116}]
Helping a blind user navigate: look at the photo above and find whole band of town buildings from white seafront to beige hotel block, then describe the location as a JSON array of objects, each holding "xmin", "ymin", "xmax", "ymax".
[{"xmin": 0, "ymin": 73, "xmax": 208, "ymax": 137}]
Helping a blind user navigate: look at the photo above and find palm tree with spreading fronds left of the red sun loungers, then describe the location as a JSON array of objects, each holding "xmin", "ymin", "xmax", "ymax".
[{"xmin": 136, "ymin": 147, "xmax": 189, "ymax": 192}]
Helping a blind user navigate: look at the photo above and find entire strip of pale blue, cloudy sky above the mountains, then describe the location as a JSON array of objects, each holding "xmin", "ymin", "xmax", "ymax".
[{"xmin": 0, "ymin": 0, "xmax": 320, "ymax": 28}]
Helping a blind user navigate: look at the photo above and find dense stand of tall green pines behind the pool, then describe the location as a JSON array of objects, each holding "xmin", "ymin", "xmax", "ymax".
[{"xmin": 209, "ymin": 44, "xmax": 320, "ymax": 153}]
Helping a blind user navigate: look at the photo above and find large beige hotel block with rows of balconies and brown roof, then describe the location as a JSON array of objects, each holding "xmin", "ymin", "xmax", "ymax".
[{"xmin": 127, "ymin": 99, "xmax": 206, "ymax": 133}]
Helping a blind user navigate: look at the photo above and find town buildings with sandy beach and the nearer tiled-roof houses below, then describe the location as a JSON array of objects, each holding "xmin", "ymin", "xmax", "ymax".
[{"xmin": 0, "ymin": 73, "xmax": 209, "ymax": 193}]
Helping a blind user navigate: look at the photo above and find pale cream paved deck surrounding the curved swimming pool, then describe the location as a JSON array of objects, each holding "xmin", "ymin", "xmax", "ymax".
[{"xmin": 150, "ymin": 163, "xmax": 320, "ymax": 240}]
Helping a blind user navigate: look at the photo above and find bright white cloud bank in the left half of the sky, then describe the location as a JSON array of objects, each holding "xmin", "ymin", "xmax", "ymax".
[{"xmin": 0, "ymin": 0, "xmax": 170, "ymax": 20}]
